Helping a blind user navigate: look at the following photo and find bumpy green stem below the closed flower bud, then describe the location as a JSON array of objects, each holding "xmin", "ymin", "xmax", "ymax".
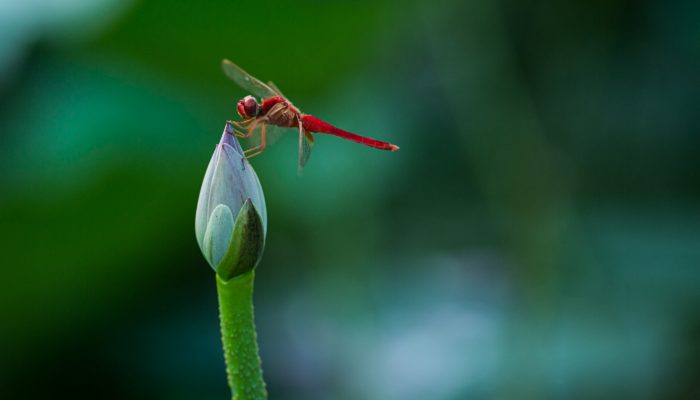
[{"xmin": 216, "ymin": 271, "xmax": 267, "ymax": 400}]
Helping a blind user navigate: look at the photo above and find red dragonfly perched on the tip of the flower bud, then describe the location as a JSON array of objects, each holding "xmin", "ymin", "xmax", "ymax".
[{"xmin": 221, "ymin": 59, "xmax": 399, "ymax": 172}]
